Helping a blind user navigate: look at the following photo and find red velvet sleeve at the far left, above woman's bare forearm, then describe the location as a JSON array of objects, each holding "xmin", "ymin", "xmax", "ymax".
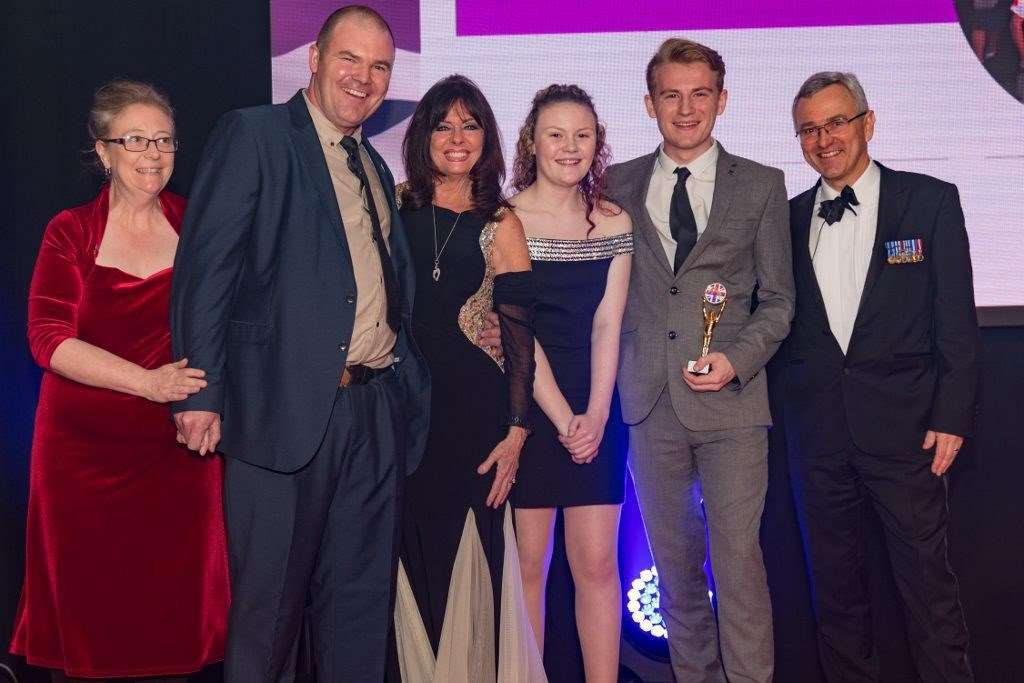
[{"xmin": 29, "ymin": 211, "xmax": 85, "ymax": 369}]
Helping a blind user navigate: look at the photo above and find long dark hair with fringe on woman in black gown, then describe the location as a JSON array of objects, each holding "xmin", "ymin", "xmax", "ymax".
[{"xmin": 401, "ymin": 74, "xmax": 507, "ymax": 220}]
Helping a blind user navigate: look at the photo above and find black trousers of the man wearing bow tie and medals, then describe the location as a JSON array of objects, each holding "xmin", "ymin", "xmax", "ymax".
[{"xmin": 788, "ymin": 441, "xmax": 974, "ymax": 683}]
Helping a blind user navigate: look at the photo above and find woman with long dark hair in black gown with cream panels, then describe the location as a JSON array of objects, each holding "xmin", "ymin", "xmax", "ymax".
[{"xmin": 390, "ymin": 76, "xmax": 546, "ymax": 683}]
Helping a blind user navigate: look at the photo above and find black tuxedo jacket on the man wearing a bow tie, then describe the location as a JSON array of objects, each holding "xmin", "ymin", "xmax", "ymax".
[{"xmin": 783, "ymin": 164, "xmax": 979, "ymax": 455}]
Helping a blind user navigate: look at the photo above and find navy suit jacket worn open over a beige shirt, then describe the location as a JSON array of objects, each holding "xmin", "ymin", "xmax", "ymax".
[{"xmin": 171, "ymin": 92, "xmax": 430, "ymax": 472}]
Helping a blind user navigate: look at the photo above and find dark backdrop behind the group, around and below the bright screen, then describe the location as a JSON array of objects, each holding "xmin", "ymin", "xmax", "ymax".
[{"xmin": 0, "ymin": 0, "xmax": 1024, "ymax": 683}]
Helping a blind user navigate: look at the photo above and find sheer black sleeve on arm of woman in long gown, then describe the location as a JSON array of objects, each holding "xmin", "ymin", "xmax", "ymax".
[{"xmin": 494, "ymin": 270, "xmax": 536, "ymax": 430}]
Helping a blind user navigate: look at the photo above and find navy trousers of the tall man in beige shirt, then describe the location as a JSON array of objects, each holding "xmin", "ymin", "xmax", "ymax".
[{"xmin": 224, "ymin": 373, "xmax": 404, "ymax": 683}]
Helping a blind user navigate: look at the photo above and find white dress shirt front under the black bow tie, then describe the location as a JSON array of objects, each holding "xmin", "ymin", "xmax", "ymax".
[{"xmin": 807, "ymin": 161, "xmax": 882, "ymax": 354}]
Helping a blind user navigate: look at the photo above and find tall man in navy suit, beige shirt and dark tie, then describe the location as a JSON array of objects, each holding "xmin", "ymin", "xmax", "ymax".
[{"xmin": 171, "ymin": 6, "xmax": 429, "ymax": 683}]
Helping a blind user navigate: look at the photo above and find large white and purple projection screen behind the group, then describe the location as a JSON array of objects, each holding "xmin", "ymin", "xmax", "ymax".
[{"xmin": 271, "ymin": 0, "xmax": 1024, "ymax": 306}]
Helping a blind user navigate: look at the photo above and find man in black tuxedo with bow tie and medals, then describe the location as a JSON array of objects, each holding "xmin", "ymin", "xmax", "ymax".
[{"xmin": 782, "ymin": 72, "xmax": 978, "ymax": 683}]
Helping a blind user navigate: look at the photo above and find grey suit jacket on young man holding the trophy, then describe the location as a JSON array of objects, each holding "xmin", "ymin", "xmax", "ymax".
[{"xmin": 607, "ymin": 148, "xmax": 795, "ymax": 430}]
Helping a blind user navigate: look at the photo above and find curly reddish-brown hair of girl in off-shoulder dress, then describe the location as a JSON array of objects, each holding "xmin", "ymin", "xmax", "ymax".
[{"xmin": 512, "ymin": 84, "xmax": 616, "ymax": 229}]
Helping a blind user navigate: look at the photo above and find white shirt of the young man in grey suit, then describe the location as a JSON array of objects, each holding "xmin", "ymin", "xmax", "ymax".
[{"xmin": 646, "ymin": 140, "xmax": 719, "ymax": 263}]
